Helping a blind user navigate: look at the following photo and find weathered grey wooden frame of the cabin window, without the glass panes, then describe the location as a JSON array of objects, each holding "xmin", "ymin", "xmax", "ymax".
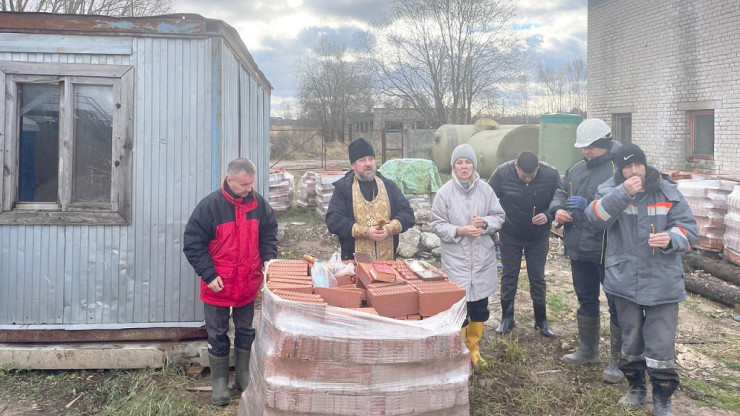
[{"xmin": 0, "ymin": 61, "xmax": 134, "ymax": 225}]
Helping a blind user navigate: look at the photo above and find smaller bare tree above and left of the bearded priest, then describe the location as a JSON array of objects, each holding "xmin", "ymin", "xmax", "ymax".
[{"xmin": 297, "ymin": 38, "xmax": 372, "ymax": 142}]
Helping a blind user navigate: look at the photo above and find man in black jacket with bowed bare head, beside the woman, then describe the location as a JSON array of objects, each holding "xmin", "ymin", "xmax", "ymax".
[{"xmin": 488, "ymin": 152, "xmax": 560, "ymax": 337}]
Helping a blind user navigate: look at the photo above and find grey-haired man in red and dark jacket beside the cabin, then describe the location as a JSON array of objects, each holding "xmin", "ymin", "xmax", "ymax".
[{"xmin": 183, "ymin": 159, "xmax": 277, "ymax": 405}]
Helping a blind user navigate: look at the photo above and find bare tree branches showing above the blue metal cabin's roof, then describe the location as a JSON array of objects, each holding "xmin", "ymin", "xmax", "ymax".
[{"xmin": 0, "ymin": 0, "xmax": 173, "ymax": 17}]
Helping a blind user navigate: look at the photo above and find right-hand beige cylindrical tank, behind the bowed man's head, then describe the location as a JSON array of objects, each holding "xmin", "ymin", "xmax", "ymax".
[{"xmin": 468, "ymin": 124, "xmax": 540, "ymax": 181}]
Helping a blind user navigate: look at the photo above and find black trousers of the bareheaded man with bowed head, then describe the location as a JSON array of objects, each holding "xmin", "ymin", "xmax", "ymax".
[{"xmin": 499, "ymin": 231, "xmax": 550, "ymax": 304}]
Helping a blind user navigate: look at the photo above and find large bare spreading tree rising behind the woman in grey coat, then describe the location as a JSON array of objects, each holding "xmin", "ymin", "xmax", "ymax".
[{"xmin": 364, "ymin": 0, "xmax": 524, "ymax": 126}]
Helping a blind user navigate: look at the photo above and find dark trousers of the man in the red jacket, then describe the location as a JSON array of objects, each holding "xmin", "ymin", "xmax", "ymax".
[{"xmin": 203, "ymin": 302, "xmax": 254, "ymax": 357}]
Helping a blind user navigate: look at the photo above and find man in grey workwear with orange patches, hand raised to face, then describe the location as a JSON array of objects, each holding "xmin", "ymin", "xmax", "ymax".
[{"xmin": 586, "ymin": 144, "xmax": 697, "ymax": 416}]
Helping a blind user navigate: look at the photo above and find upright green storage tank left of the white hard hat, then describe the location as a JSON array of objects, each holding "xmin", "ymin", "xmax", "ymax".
[{"xmin": 538, "ymin": 114, "xmax": 583, "ymax": 175}]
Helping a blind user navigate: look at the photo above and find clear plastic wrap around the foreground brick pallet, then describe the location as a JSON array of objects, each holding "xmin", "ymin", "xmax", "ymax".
[{"xmin": 243, "ymin": 264, "xmax": 470, "ymax": 416}]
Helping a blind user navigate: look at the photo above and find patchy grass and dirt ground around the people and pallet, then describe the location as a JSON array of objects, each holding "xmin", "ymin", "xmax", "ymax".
[{"xmin": 0, "ymin": 161, "xmax": 740, "ymax": 416}]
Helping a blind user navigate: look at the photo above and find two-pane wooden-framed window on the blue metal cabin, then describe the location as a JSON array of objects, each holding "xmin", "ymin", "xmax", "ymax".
[{"xmin": 0, "ymin": 61, "xmax": 133, "ymax": 224}]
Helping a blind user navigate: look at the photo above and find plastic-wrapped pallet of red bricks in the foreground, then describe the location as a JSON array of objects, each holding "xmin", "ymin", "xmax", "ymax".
[{"xmin": 243, "ymin": 255, "xmax": 471, "ymax": 416}]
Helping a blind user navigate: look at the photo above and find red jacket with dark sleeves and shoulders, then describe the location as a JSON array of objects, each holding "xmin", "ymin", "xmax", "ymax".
[{"xmin": 183, "ymin": 181, "xmax": 277, "ymax": 307}]
